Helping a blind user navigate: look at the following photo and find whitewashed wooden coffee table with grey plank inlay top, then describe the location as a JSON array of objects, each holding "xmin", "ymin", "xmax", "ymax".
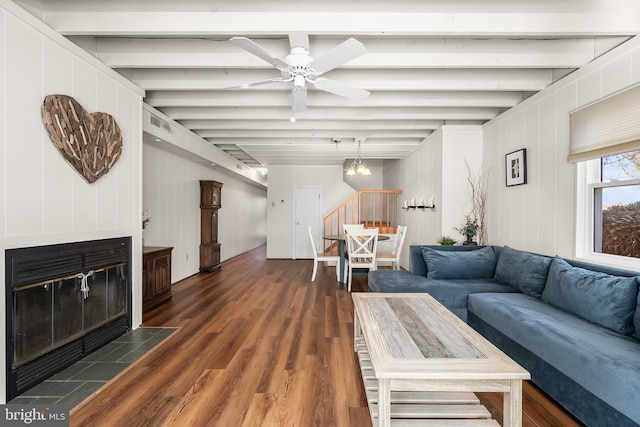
[{"xmin": 352, "ymin": 293, "xmax": 530, "ymax": 427}]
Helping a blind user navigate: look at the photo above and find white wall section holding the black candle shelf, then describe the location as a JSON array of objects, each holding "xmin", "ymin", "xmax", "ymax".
[{"xmin": 384, "ymin": 126, "xmax": 482, "ymax": 269}]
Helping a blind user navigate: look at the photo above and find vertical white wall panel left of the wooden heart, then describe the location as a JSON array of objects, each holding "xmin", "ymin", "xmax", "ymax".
[{"xmin": 4, "ymin": 15, "xmax": 43, "ymax": 236}]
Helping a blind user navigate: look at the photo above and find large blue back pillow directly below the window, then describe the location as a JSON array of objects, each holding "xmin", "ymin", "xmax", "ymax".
[{"xmin": 542, "ymin": 256, "xmax": 638, "ymax": 335}]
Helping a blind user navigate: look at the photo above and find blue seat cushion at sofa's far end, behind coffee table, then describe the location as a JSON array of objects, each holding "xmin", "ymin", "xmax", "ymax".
[{"xmin": 368, "ymin": 270, "xmax": 516, "ymax": 321}]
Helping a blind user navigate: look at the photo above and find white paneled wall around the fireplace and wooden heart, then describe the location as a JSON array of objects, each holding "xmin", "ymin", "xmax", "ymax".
[{"xmin": 0, "ymin": 0, "xmax": 143, "ymax": 403}]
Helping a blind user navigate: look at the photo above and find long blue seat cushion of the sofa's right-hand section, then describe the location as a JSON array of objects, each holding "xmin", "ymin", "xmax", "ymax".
[{"xmin": 468, "ymin": 293, "xmax": 640, "ymax": 422}]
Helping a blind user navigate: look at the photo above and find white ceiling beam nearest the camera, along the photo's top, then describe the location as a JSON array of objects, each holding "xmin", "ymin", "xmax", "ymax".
[{"xmin": 44, "ymin": 11, "xmax": 640, "ymax": 38}]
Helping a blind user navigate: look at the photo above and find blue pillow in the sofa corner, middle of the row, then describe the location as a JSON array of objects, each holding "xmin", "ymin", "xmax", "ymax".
[{"xmin": 494, "ymin": 246, "xmax": 552, "ymax": 298}]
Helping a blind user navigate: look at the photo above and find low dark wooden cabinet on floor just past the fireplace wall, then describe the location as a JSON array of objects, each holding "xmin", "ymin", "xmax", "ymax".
[{"xmin": 142, "ymin": 246, "xmax": 173, "ymax": 313}]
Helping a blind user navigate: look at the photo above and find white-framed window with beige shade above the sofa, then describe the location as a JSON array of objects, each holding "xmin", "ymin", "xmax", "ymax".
[{"xmin": 569, "ymin": 84, "xmax": 640, "ymax": 270}]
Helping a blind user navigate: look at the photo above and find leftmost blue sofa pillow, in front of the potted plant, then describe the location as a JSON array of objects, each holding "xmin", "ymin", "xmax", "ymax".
[{"xmin": 422, "ymin": 246, "xmax": 497, "ymax": 279}]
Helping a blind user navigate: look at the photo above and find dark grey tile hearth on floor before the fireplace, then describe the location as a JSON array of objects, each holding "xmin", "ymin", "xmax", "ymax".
[{"xmin": 9, "ymin": 328, "xmax": 177, "ymax": 408}]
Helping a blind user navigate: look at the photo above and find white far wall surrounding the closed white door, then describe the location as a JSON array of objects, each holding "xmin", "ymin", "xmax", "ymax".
[{"xmin": 267, "ymin": 165, "xmax": 358, "ymax": 258}]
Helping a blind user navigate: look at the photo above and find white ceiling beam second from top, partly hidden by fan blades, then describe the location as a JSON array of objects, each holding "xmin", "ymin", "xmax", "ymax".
[{"xmin": 96, "ymin": 38, "xmax": 595, "ymax": 69}]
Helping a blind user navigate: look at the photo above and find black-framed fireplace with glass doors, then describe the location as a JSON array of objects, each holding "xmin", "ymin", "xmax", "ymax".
[{"xmin": 5, "ymin": 237, "xmax": 131, "ymax": 400}]
